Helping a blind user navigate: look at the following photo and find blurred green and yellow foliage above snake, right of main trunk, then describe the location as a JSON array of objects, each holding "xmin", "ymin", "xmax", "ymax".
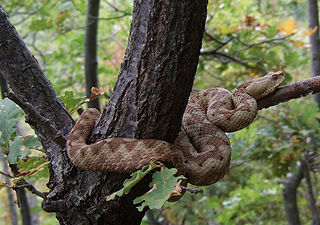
[{"xmin": 195, "ymin": 0, "xmax": 312, "ymax": 89}]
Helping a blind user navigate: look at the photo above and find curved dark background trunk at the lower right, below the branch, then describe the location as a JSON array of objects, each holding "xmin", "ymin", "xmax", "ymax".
[{"xmin": 282, "ymin": 164, "xmax": 303, "ymax": 225}]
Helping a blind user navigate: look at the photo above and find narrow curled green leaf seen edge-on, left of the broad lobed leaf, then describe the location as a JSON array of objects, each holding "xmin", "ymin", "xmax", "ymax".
[{"xmin": 106, "ymin": 163, "xmax": 160, "ymax": 201}]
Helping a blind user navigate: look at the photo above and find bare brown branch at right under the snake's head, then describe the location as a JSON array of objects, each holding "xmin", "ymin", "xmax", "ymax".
[{"xmin": 258, "ymin": 76, "xmax": 320, "ymax": 110}]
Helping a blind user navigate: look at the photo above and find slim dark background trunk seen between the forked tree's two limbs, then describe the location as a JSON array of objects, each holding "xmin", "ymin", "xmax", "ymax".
[{"xmin": 84, "ymin": 0, "xmax": 100, "ymax": 110}]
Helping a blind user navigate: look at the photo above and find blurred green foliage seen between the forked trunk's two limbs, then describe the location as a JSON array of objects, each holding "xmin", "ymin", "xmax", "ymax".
[{"xmin": 1, "ymin": 0, "xmax": 132, "ymax": 105}]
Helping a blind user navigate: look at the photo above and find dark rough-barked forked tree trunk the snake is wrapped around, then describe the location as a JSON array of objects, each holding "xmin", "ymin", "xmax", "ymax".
[{"xmin": 0, "ymin": 0, "xmax": 207, "ymax": 225}]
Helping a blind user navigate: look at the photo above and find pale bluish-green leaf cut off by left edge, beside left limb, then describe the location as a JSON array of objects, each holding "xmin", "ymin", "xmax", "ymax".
[{"xmin": 0, "ymin": 98, "xmax": 23, "ymax": 146}]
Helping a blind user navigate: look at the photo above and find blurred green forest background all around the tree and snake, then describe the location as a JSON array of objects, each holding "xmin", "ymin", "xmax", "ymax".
[{"xmin": 0, "ymin": 0, "xmax": 320, "ymax": 225}]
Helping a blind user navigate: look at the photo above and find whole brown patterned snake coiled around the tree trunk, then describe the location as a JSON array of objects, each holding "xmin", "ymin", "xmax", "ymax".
[{"xmin": 67, "ymin": 71, "xmax": 284, "ymax": 185}]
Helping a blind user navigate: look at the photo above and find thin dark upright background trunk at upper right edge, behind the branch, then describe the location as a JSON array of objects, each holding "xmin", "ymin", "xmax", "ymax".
[{"xmin": 308, "ymin": 0, "xmax": 320, "ymax": 107}]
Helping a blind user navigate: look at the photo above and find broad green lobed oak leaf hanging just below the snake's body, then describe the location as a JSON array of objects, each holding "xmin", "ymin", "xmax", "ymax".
[{"xmin": 133, "ymin": 168, "xmax": 184, "ymax": 211}]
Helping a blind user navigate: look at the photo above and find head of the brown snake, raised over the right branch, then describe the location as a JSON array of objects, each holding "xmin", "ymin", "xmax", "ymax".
[{"xmin": 239, "ymin": 71, "xmax": 285, "ymax": 99}]
